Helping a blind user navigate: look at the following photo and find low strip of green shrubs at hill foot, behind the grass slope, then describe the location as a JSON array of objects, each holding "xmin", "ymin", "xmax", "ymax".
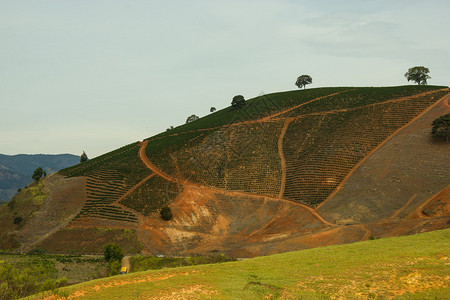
[{"xmin": 130, "ymin": 254, "xmax": 236, "ymax": 272}]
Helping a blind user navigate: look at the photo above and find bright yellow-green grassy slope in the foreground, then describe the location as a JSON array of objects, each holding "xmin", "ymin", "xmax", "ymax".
[{"xmin": 35, "ymin": 229, "xmax": 450, "ymax": 299}]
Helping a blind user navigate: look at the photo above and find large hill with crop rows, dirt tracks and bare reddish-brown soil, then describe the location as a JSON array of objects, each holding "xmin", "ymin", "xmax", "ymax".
[{"xmin": 0, "ymin": 86, "xmax": 450, "ymax": 257}]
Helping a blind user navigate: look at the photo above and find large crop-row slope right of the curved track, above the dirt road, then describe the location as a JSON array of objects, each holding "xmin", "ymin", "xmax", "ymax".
[{"xmin": 147, "ymin": 87, "xmax": 448, "ymax": 206}]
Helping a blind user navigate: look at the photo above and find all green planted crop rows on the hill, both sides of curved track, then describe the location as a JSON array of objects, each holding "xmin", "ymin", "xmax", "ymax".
[{"xmin": 61, "ymin": 86, "xmax": 448, "ymax": 213}]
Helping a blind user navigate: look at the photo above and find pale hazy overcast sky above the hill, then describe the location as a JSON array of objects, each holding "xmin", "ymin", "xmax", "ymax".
[{"xmin": 0, "ymin": 0, "xmax": 450, "ymax": 158}]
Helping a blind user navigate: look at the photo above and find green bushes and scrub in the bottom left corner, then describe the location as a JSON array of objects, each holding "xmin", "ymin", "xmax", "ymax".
[{"xmin": 0, "ymin": 249, "xmax": 106, "ymax": 299}]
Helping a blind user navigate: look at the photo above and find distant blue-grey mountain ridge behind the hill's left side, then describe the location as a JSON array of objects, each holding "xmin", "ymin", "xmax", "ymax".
[{"xmin": 0, "ymin": 154, "xmax": 80, "ymax": 203}]
